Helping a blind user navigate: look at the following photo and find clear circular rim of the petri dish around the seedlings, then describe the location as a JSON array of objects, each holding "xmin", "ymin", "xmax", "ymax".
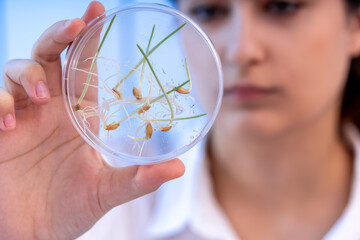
[{"xmin": 62, "ymin": 3, "xmax": 223, "ymax": 166}]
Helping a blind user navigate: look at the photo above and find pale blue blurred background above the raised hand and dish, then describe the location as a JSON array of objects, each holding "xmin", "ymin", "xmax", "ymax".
[{"xmin": 0, "ymin": 0, "xmax": 171, "ymax": 86}]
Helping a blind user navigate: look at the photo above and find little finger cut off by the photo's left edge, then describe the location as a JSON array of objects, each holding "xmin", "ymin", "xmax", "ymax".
[{"xmin": 0, "ymin": 88, "xmax": 16, "ymax": 131}]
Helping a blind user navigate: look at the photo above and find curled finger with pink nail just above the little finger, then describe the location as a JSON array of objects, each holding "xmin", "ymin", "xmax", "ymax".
[{"xmin": 4, "ymin": 59, "xmax": 50, "ymax": 108}]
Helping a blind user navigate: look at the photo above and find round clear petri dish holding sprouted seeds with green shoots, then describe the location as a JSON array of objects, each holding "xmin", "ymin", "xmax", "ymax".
[{"xmin": 62, "ymin": 4, "xmax": 223, "ymax": 167}]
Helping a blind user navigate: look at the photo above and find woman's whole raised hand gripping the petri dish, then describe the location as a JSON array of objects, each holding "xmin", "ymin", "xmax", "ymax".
[{"xmin": 0, "ymin": 2, "xmax": 184, "ymax": 239}]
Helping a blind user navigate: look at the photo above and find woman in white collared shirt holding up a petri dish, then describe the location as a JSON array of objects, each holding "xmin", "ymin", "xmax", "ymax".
[{"xmin": 0, "ymin": 0, "xmax": 360, "ymax": 239}]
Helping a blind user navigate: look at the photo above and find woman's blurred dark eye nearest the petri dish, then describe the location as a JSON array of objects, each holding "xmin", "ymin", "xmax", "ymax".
[{"xmin": 190, "ymin": 4, "xmax": 229, "ymax": 22}]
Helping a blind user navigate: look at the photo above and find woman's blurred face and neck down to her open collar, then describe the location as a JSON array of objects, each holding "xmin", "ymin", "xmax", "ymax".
[{"xmin": 178, "ymin": 0, "xmax": 360, "ymax": 239}]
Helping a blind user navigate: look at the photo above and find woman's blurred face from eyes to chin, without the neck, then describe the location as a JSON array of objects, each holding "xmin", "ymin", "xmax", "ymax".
[{"xmin": 179, "ymin": 0, "xmax": 360, "ymax": 137}]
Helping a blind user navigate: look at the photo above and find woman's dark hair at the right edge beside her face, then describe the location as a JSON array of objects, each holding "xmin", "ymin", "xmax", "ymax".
[{"xmin": 341, "ymin": 0, "xmax": 360, "ymax": 129}]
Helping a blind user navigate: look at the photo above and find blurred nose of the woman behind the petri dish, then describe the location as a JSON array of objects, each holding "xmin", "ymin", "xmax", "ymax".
[{"xmin": 225, "ymin": 9, "xmax": 266, "ymax": 71}]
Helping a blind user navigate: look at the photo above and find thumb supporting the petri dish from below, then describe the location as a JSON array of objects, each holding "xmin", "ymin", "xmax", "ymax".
[{"xmin": 98, "ymin": 159, "xmax": 185, "ymax": 213}]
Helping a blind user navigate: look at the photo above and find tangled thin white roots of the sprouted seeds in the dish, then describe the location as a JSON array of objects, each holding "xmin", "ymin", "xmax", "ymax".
[{"xmin": 74, "ymin": 57, "xmax": 197, "ymax": 159}]
